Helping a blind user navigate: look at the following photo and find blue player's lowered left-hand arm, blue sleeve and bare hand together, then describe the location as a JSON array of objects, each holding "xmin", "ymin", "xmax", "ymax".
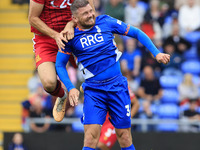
[{"xmin": 55, "ymin": 51, "xmax": 79, "ymax": 106}]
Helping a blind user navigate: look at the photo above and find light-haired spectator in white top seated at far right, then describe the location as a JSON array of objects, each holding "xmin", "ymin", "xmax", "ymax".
[{"xmin": 178, "ymin": 73, "xmax": 199, "ymax": 105}]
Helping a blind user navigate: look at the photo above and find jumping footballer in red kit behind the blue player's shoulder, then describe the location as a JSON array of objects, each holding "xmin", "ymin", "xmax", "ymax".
[{"xmin": 28, "ymin": 0, "xmax": 94, "ymax": 122}]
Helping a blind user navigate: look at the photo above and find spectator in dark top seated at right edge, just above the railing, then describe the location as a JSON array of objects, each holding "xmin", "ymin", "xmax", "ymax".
[{"xmin": 183, "ymin": 99, "xmax": 200, "ymax": 132}]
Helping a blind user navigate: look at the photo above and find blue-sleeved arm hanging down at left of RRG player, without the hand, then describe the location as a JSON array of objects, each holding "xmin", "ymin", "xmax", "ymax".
[{"xmin": 55, "ymin": 52, "xmax": 75, "ymax": 92}]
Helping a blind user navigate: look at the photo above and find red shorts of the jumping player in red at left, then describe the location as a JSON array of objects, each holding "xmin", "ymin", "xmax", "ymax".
[{"xmin": 33, "ymin": 35, "xmax": 58, "ymax": 68}]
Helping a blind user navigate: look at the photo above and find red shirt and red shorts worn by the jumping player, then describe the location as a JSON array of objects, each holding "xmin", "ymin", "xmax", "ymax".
[{"xmin": 31, "ymin": 0, "xmax": 73, "ymax": 67}]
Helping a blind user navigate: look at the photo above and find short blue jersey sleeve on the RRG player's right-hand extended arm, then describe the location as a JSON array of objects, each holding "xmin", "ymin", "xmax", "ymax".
[{"xmin": 105, "ymin": 16, "xmax": 130, "ymax": 35}]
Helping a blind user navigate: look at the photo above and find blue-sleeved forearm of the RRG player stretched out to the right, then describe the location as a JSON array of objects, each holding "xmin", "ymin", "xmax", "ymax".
[{"xmin": 127, "ymin": 26, "xmax": 160, "ymax": 57}]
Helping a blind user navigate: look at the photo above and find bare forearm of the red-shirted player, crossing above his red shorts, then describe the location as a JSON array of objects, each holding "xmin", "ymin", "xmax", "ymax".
[{"xmin": 29, "ymin": 17, "xmax": 58, "ymax": 38}]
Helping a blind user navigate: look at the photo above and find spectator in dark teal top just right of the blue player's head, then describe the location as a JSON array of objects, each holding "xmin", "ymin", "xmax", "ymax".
[{"xmin": 105, "ymin": 0, "xmax": 124, "ymax": 21}]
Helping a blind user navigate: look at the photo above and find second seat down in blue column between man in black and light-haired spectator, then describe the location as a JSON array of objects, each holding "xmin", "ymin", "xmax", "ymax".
[{"xmin": 161, "ymin": 89, "xmax": 179, "ymax": 104}]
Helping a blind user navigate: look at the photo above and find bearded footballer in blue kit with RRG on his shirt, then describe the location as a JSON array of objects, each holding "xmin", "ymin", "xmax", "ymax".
[{"xmin": 56, "ymin": 0, "xmax": 170, "ymax": 150}]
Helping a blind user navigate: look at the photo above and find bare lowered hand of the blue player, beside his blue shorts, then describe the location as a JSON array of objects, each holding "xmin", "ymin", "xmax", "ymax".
[{"xmin": 69, "ymin": 88, "xmax": 80, "ymax": 106}]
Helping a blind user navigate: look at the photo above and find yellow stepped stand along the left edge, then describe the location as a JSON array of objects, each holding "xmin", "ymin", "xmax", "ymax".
[{"xmin": 0, "ymin": 0, "xmax": 34, "ymax": 150}]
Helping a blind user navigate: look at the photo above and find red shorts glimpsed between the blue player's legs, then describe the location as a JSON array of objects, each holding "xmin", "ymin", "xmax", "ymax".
[{"xmin": 99, "ymin": 119, "xmax": 117, "ymax": 149}]
